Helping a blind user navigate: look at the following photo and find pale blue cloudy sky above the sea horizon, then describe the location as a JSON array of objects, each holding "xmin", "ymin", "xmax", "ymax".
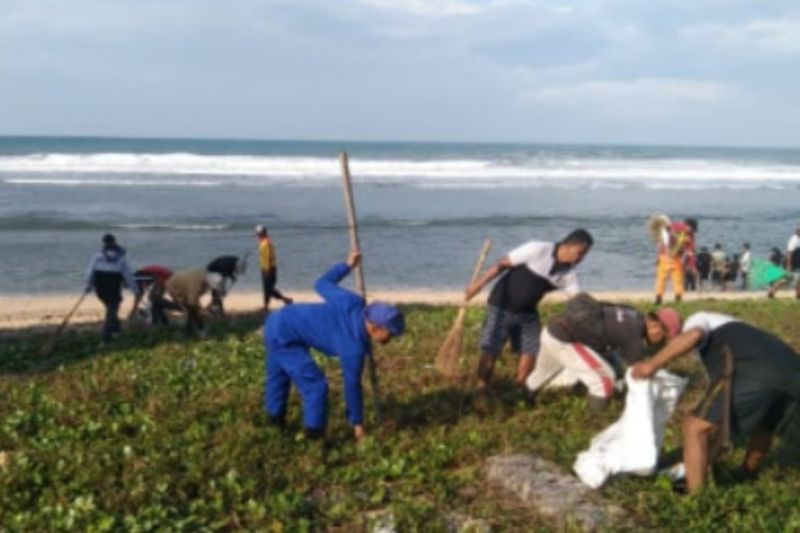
[{"xmin": 0, "ymin": 0, "xmax": 800, "ymax": 146}]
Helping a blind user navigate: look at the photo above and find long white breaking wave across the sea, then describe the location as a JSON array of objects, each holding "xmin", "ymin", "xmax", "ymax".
[{"xmin": 0, "ymin": 153, "xmax": 800, "ymax": 189}]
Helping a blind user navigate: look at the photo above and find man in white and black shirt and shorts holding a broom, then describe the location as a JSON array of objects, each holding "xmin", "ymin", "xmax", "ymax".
[{"xmin": 465, "ymin": 229, "xmax": 594, "ymax": 389}]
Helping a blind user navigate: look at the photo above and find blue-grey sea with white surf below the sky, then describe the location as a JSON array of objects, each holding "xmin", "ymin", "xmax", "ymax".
[{"xmin": 0, "ymin": 137, "xmax": 800, "ymax": 294}]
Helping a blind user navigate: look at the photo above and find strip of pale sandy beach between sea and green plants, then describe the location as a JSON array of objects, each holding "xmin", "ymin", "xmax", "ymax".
[{"xmin": 0, "ymin": 289, "xmax": 780, "ymax": 331}]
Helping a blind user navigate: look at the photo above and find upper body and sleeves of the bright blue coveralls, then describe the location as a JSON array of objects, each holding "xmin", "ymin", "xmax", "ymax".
[{"xmin": 268, "ymin": 263, "xmax": 371, "ymax": 425}]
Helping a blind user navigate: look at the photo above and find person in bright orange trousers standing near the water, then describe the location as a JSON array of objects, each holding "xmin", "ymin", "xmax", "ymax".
[{"xmin": 656, "ymin": 218, "xmax": 697, "ymax": 305}]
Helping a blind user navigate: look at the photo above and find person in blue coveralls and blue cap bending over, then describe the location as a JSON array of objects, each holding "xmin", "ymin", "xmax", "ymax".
[{"xmin": 264, "ymin": 250, "xmax": 405, "ymax": 440}]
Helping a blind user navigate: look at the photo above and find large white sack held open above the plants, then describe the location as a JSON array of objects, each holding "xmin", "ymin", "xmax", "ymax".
[{"xmin": 572, "ymin": 369, "xmax": 688, "ymax": 489}]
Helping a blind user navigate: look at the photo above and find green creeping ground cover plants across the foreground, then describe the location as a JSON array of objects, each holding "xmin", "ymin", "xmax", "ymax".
[{"xmin": 0, "ymin": 301, "xmax": 800, "ymax": 532}]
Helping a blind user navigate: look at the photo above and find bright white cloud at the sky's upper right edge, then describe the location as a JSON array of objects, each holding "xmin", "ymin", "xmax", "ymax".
[{"xmin": 683, "ymin": 18, "xmax": 800, "ymax": 55}]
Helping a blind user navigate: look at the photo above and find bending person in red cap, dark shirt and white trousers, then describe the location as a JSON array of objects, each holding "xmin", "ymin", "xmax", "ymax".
[{"xmin": 525, "ymin": 293, "xmax": 681, "ymax": 411}]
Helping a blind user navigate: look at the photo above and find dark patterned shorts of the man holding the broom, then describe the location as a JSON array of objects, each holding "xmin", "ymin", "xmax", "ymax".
[{"xmin": 481, "ymin": 305, "xmax": 541, "ymax": 357}]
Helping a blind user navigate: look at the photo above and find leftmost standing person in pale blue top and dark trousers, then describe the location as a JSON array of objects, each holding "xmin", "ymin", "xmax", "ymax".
[{"xmin": 86, "ymin": 233, "xmax": 140, "ymax": 342}]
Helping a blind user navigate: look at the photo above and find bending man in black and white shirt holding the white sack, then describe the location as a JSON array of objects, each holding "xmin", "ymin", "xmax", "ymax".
[{"xmin": 633, "ymin": 312, "xmax": 800, "ymax": 493}]
